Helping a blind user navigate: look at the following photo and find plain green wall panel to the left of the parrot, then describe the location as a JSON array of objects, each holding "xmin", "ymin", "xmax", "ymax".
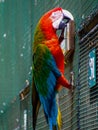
[{"xmin": 0, "ymin": 0, "xmax": 32, "ymax": 110}]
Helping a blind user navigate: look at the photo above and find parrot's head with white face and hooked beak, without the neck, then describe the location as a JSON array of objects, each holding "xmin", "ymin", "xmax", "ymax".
[{"xmin": 41, "ymin": 7, "xmax": 74, "ymax": 30}]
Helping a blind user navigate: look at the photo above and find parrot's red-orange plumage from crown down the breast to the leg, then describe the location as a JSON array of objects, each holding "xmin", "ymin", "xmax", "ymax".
[{"xmin": 40, "ymin": 8, "xmax": 71, "ymax": 90}]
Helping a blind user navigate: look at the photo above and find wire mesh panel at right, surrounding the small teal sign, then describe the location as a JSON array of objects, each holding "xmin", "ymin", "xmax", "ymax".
[{"xmin": 79, "ymin": 25, "xmax": 98, "ymax": 130}]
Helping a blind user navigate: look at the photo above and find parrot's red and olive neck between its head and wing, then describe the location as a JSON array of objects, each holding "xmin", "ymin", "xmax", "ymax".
[{"xmin": 34, "ymin": 22, "xmax": 59, "ymax": 47}]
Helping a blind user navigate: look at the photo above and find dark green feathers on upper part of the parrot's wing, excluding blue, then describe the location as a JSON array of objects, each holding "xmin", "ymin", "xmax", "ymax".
[{"xmin": 33, "ymin": 44, "xmax": 51, "ymax": 96}]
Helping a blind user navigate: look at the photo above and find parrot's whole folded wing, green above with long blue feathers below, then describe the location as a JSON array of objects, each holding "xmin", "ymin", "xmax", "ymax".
[{"xmin": 33, "ymin": 44, "xmax": 64, "ymax": 129}]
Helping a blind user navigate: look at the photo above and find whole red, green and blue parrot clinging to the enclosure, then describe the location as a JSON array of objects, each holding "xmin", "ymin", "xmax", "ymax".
[{"xmin": 32, "ymin": 7, "xmax": 73, "ymax": 130}]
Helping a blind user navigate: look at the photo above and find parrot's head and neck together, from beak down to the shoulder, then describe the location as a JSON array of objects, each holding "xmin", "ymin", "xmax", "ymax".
[{"xmin": 34, "ymin": 7, "xmax": 74, "ymax": 45}]
